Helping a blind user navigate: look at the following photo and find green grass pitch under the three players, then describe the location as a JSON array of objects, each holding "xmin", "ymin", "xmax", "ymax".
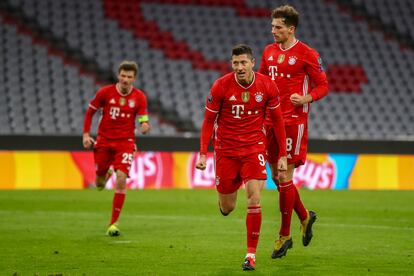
[{"xmin": 0, "ymin": 190, "xmax": 414, "ymax": 275}]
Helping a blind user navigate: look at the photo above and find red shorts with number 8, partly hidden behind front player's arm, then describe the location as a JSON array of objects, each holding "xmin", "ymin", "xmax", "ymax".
[{"xmin": 266, "ymin": 124, "xmax": 308, "ymax": 167}]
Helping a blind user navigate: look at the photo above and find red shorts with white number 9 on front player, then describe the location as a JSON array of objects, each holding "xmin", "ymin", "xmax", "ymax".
[{"xmin": 215, "ymin": 152, "xmax": 267, "ymax": 194}]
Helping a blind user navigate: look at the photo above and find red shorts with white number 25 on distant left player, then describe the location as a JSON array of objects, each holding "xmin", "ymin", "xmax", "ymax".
[{"xmin": 93, "ymin": 137, "xmax": 136, "ymax": 176}]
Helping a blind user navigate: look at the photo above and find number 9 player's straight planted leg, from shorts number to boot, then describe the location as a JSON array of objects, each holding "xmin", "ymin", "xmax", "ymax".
[{"xmin": 240, "ymin": 152, "xmax": 267, "ymax": 270}]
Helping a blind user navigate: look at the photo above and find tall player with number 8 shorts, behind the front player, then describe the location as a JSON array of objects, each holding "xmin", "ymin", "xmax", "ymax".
[{"xmin": 259, "ymin": 5, "xmax": 328, "ymax": 258}]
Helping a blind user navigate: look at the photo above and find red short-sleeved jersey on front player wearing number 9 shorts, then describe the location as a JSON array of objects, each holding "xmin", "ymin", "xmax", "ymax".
[{"xmin": 206, "ymin": 73, "xmax": 279, "ymax": 156}]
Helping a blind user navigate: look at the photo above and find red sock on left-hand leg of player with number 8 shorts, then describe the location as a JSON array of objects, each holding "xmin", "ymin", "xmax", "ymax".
[{"xmin": 278, "ymin": 181, "xmax": 297, "ymax": 236}]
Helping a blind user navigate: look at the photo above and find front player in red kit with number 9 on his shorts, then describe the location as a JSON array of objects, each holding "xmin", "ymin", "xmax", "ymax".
[{"xmin": 196, "ymin": 45, "xmax": 287, "ymax": 270}]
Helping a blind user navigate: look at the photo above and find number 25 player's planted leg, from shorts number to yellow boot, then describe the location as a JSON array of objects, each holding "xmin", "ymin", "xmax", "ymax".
[{"xmin": 108, "ymin": 142, "xmax": 135, "ymax": 236}]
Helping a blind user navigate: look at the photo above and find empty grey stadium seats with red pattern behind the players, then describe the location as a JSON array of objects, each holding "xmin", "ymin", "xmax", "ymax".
[{"xmin": 0, "ymin": 0, "xmax": 414, "ymax": 139}]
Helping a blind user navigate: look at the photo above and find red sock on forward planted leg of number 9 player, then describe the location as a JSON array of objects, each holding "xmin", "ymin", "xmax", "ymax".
[{"xmin": 246, "ymin": 205, "xmax": 262, "ymax": 254}]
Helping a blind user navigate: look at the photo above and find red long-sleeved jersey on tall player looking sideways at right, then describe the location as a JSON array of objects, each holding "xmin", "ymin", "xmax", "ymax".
[{"xmin": 259, "ymin": 40, "xmax": 328, "ymax": 125}]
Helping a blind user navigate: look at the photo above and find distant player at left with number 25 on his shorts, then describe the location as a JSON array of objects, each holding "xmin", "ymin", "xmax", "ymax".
[{"xmin": 83, "ymin": 61, "xmax": 150, "ymax": 236}]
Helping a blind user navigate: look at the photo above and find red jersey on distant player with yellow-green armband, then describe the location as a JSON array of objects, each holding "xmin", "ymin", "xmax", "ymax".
[{"xmin": 89, "ymin": 85, "xmax": 148, "ymax": 139}]
